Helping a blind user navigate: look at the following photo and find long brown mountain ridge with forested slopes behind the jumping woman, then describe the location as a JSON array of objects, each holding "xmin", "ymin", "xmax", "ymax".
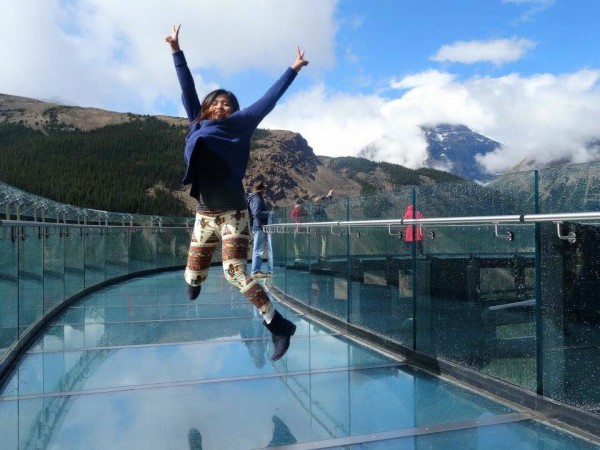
[{"xmin": 0, "ymin": 94, "xmax": 459, "ymax": 215}]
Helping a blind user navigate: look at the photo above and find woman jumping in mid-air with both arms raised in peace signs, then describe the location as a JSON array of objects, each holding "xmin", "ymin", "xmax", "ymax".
[{"xmin": 165, "ymin": 25, "xmax": 308, "ymax": 361}]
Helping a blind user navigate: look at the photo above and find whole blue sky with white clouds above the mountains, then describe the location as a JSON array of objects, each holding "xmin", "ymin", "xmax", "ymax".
[{"xmin": 0, "ymin": 0, "xmax": 600, "ymax": 173}]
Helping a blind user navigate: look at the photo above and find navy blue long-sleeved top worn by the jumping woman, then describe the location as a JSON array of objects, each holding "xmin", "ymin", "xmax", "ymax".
[{"xmin": 173, "ymin": 51, "xmax": 297, "ymax": 211}]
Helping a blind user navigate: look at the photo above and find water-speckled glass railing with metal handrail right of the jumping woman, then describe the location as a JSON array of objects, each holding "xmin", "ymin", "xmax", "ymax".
[{"xmin": 267, "ymin": 163, "xmax": 600, "ymax": 422}]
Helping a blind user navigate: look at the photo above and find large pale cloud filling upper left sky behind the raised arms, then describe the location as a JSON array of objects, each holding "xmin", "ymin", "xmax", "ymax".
[{"xmin": 0, "ymin": 0, "xmax": 337, "ymax": 112}]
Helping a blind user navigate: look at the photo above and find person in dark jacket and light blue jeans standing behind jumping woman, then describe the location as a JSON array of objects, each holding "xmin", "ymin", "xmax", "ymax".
[{"xmin": 248, "ymin": 181, "xmax": 273, "ymax": 278}]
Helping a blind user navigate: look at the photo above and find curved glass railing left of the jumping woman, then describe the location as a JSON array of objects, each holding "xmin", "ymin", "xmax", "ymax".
[{"xmin": 0, "ymin": 183, "xmax": 193, "ymax": 369}]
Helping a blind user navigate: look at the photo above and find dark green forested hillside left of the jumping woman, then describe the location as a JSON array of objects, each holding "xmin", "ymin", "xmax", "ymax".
[{"xmin": 0, "ymin": 117, "xmax": 188, "ymax": 215}]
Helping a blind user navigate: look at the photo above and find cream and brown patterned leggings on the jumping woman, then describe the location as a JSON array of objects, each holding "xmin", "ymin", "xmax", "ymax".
[{"xmin": 185, "ymin": 210, "xmax": 273, "ymax": 315}]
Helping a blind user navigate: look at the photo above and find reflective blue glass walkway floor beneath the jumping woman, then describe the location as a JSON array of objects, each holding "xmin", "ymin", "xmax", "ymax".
[{"xmin": 0, "ymin": 268, "xmax": 599, "ymax": 450}]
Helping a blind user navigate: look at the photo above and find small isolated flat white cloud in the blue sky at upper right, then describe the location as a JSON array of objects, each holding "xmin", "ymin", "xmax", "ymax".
[{"xmin": 431, "ymin": 38, "xmax": 535, "ymax": 65}]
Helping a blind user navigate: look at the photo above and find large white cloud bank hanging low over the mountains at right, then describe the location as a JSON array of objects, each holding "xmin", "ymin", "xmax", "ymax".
[{"xmin": 263, "ymin": 70, "xmax": 600, "ymax": 173}]
